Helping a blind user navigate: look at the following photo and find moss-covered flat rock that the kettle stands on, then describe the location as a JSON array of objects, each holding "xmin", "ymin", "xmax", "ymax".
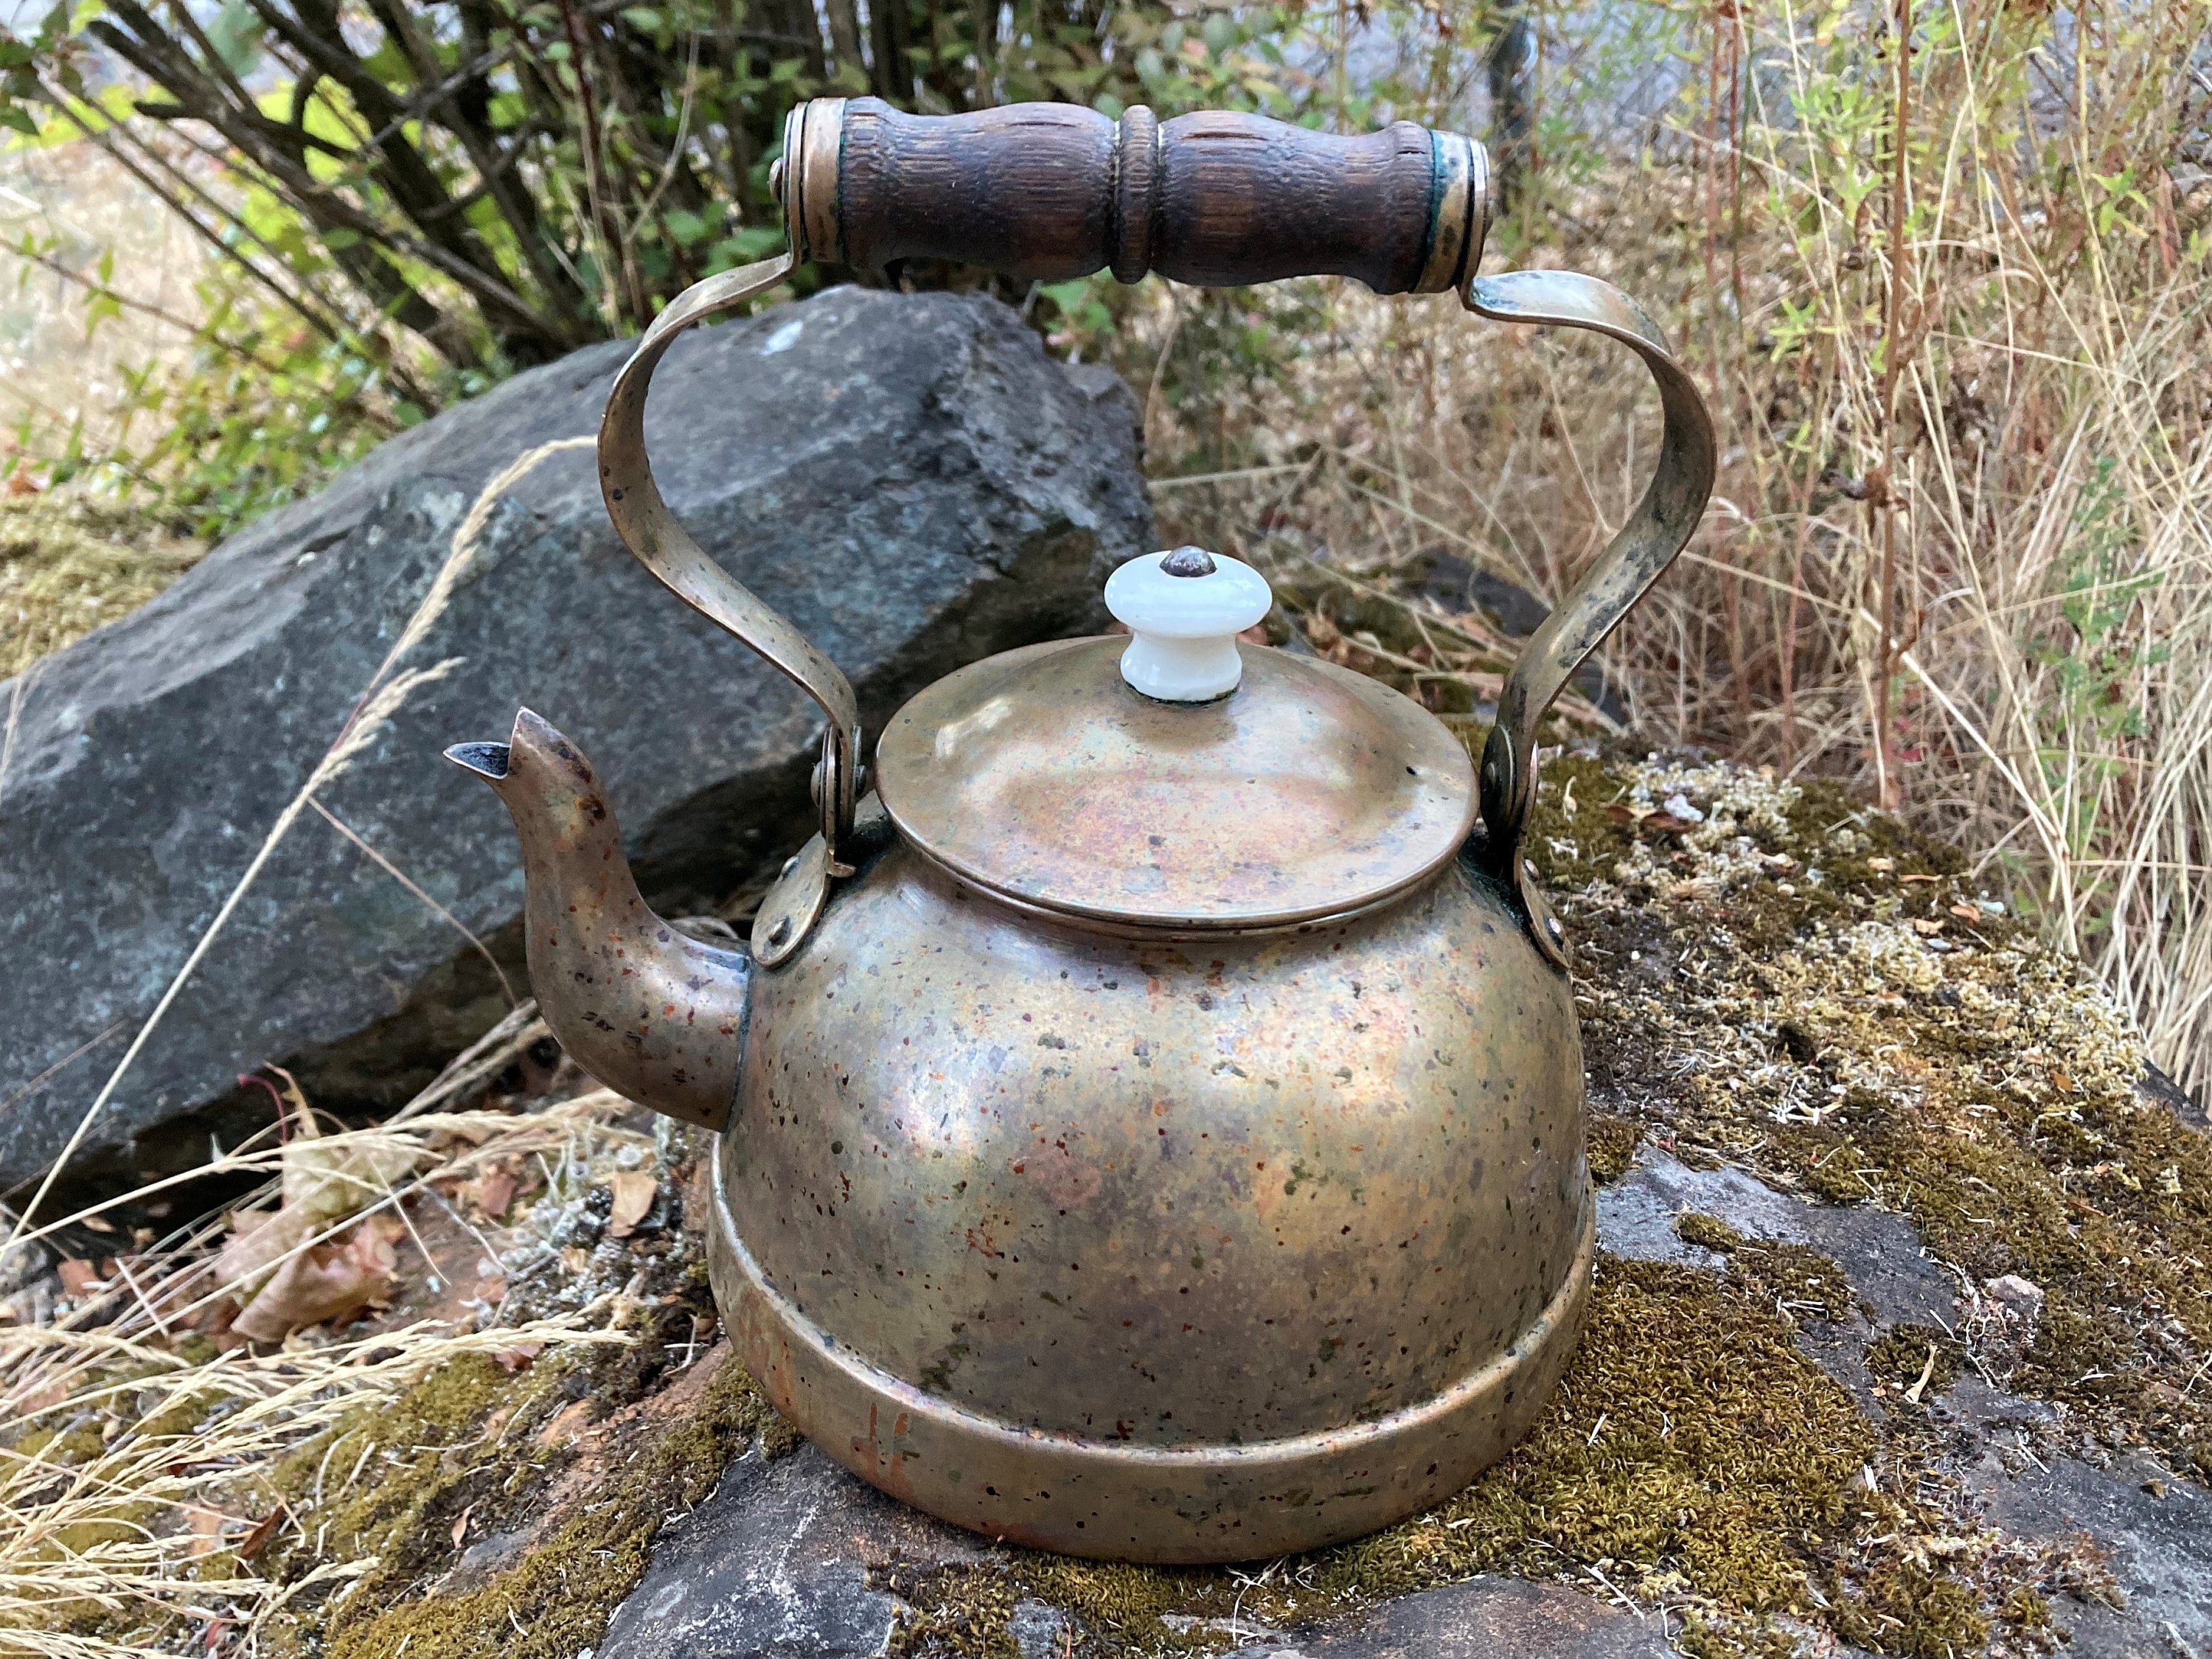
[{"xmin": 199, "ymin": 757, "xmax": 2212, "ymax": 1659}]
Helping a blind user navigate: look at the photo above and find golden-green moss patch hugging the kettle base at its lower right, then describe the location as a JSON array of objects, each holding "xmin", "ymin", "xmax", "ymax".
[{"xmin": 878, "ymin": 1245, "xmax": 1898, "ymax": 1659}]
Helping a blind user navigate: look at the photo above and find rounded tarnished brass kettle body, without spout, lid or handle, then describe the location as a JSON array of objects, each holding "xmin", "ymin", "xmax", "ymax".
[{"xmin": 714, "ymin": 847, "xmax": 1590, "ymax": 1559}]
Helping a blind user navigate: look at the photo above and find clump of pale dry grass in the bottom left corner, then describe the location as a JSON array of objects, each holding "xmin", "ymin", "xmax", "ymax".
[{"xmin": 0, "ymin": 1091, "xmax": 655, "ymax": 1659}]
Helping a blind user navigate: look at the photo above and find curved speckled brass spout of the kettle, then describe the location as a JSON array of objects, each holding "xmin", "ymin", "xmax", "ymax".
[{"xmin": 445, "ymin": 708, "xmax": 752, "ymax": 1130}]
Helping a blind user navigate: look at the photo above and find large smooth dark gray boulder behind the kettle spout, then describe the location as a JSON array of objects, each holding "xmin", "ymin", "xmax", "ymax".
[{"xmin": 0, "ymin": 288, "xmax": 1152, "ymax": 1192}]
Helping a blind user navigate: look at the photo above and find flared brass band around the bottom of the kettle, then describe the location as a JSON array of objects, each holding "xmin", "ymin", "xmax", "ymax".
[{"xmin": 708, "ymin": 1159, "xmax": 1597, "ymax": 1566}]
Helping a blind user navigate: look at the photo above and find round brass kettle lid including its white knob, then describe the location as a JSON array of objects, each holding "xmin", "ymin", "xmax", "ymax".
[{"xmin": 876, "ymin": 549, "xmax": 1475, "ymax": 931}]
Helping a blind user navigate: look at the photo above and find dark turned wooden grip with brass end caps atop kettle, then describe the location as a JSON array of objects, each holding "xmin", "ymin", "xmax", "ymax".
[{"xmin": 776, "ymin": 97, "xmax": 1489, "ymax": 294}]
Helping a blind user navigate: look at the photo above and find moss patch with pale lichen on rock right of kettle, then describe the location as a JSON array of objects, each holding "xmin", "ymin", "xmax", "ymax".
[{"xmin": 1528, "ymin": 759, "xmax": 2212, "ymax": 1475}]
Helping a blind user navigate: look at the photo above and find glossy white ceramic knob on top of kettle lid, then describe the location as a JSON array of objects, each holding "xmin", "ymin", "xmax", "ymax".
[{"xmin": 1106, "ymin": 546, "xmax": 1274, "ymax": 703}]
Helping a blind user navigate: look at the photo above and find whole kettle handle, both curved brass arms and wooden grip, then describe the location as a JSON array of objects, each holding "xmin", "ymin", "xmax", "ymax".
[{"xmin": 599, "ymin": 97, "xmax": 1714, "ymax": 947}]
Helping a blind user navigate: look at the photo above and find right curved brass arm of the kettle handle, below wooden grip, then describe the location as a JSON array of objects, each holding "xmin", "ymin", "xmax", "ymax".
[{"xmin": 1467, "ymin": 270, "xmax": 1714, "ymax": 967}]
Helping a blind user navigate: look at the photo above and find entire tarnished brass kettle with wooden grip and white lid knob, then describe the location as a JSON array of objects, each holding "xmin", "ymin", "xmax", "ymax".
[{"xmin": 451, "ymin": 100, "xmax": 1712, "ymax": 1562}]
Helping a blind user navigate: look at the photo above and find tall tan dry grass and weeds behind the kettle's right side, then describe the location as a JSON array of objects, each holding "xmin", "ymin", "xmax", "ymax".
[{"xmin": 1133, "ymin": 0, "xmax": 2212, "ymax": 1091}]
